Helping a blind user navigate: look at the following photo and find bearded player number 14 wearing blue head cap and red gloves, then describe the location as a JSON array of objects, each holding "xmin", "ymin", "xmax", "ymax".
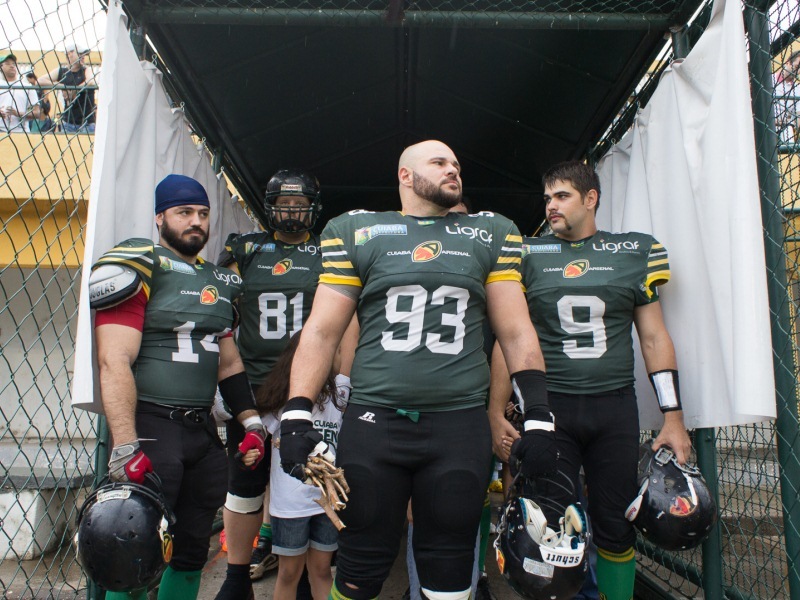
[{"xmin": 89, "ymin": 175, "xmax": 266, "ymax": 600}]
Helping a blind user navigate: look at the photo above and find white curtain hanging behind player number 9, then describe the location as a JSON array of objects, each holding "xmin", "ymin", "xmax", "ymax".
[{"xmin": 598, "ymin": 0, "xmax": 776, "ymax": 429}]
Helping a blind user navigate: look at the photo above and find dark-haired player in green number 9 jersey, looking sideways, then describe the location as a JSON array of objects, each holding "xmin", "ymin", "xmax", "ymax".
[{"xmin": 490, "ymin": 161, "xmax": 691, "ymax": 600}]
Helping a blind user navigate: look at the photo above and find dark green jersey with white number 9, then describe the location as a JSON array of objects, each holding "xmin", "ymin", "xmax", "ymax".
[{"xmin": 522, "ymin": 231, "xmax": 670, "ymax": 394}]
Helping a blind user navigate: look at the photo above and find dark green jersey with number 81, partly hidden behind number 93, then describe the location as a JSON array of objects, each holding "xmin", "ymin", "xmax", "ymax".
[{"xmin": 225, "ymin": 232, "xmax": 322, "ymax": 384}]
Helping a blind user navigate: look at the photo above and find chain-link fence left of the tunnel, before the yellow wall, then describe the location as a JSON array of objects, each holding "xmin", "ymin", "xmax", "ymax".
[{"xmin": 0, "ymin": 0, "xmax": 104, "ymax": 598}]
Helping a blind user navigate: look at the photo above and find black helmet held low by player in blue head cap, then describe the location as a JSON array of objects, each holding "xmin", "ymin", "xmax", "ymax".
[{"xmin": 75, "ymin": 474, "xmax": 175, "ymax": 592}]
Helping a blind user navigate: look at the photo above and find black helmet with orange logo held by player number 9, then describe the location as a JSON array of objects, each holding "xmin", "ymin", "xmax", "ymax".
[{"xmin": 625, "ymin": 440, "xmax": 717, "ymax": 551}]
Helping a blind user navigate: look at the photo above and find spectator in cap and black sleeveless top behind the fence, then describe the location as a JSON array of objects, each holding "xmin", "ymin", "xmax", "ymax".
[{"xmin": 39, "ymin": 44, "xmax": 97, "ymax": 133}]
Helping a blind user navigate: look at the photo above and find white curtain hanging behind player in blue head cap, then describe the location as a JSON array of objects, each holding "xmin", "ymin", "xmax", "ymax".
[{"xmin": 72, "ymin": 1, "xmax": 253, "ymax": 412}]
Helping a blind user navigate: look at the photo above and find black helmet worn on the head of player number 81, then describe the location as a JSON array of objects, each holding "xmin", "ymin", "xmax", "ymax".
[{"xmin": 264, "ymin": 169, "xmax": 322, "ymax": 233}]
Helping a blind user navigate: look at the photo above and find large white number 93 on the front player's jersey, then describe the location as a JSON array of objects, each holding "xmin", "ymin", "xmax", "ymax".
[{"xmin": 381, "ymin": 285, "xmax": 469, "ymax": 355}]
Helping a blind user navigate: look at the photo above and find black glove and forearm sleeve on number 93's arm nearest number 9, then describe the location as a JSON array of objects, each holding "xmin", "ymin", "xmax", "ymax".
[{"xmin": 511, "ymin": 369, "xmax": 558, "ymax": 477}]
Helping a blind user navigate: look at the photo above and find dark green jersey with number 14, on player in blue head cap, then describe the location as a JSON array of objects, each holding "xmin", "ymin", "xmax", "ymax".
[{"xmin": 95, "ymin": 238, "xmax": 242, "ymax": 407}]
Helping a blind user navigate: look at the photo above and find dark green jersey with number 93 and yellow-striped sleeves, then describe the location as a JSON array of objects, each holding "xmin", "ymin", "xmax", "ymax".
[{"xmin": 320, "ymin": 211, "xmax": 522, "ymax": 411}]
